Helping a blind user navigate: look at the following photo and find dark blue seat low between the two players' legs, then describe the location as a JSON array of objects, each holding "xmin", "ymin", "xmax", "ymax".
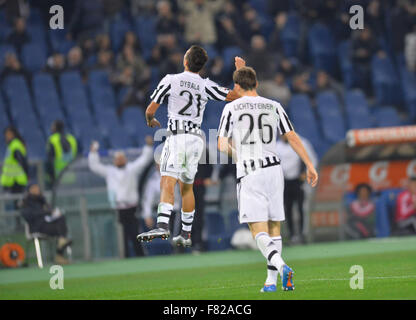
[{"xmin": 205, "ymin": 212, "xmax": 230, "ymax": 251}]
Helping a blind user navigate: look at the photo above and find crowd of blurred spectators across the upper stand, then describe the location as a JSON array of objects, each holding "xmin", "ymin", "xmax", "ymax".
[{"xmin": 0, "ymin": 0, "xmax": 416, "ymax": 115}]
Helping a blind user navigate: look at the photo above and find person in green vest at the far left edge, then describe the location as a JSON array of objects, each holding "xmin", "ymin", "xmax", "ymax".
[{"xmin": 0, "ymin": 126, "xmax": 29, "ymax": 193}]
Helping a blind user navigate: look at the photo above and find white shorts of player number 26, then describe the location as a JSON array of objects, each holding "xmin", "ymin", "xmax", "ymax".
[{"xmin": 237, "ymin": 165, "xmax": 285, "ymax": 223}]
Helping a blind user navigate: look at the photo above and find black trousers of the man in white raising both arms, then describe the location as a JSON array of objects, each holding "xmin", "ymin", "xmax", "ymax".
[{"xmin": 117, "ymin": 207, "xmax": 144, "ymax": 258}]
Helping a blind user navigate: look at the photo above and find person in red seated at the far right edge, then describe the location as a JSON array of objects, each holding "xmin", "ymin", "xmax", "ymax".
[{"xmin": 394, "ymin": 176, "xmax": 416, "ymax": 233}]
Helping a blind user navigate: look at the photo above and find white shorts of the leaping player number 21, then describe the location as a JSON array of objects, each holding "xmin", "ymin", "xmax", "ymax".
[{"xmin": 160, "ymin": 133, "xmax": 205, "ymax": 184}]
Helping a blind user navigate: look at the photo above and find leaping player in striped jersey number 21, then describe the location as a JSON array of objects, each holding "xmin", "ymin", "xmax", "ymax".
[{"xmin": 137, "ymin": 45, "xmax": 245, "ymax": 247}]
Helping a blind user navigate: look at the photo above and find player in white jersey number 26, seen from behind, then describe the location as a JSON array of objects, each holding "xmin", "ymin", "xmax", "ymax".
[{"xmin": 218, "ymin": 67, "xmax": 318, "ymax": 292}]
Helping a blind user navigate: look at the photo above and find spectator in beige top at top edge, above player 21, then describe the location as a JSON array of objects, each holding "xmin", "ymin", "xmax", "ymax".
[{"xmin": 178, "ymin": 0, "xmax": 225, "ymax": 45}]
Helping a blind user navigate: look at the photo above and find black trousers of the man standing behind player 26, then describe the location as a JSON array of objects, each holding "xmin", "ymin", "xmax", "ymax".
[{"xmin": 284, "ymin": 179, "xmax": 305, "ymax": 236}]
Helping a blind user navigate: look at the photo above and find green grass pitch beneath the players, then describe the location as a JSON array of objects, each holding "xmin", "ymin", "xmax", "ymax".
[{"xmin": 0, "ymin": 237, "xmax": 416, "ymax": 300}]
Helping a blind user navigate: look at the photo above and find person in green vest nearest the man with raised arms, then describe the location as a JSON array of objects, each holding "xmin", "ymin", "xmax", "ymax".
[{"xmin": 46, "ymin": 120, "xmax": 78, "ymax": 184}]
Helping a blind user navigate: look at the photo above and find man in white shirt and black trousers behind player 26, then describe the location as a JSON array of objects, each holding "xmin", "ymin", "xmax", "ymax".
[{"xmin": 277, "ymin": 136, "xmax": 318, "ymax": 243}]
